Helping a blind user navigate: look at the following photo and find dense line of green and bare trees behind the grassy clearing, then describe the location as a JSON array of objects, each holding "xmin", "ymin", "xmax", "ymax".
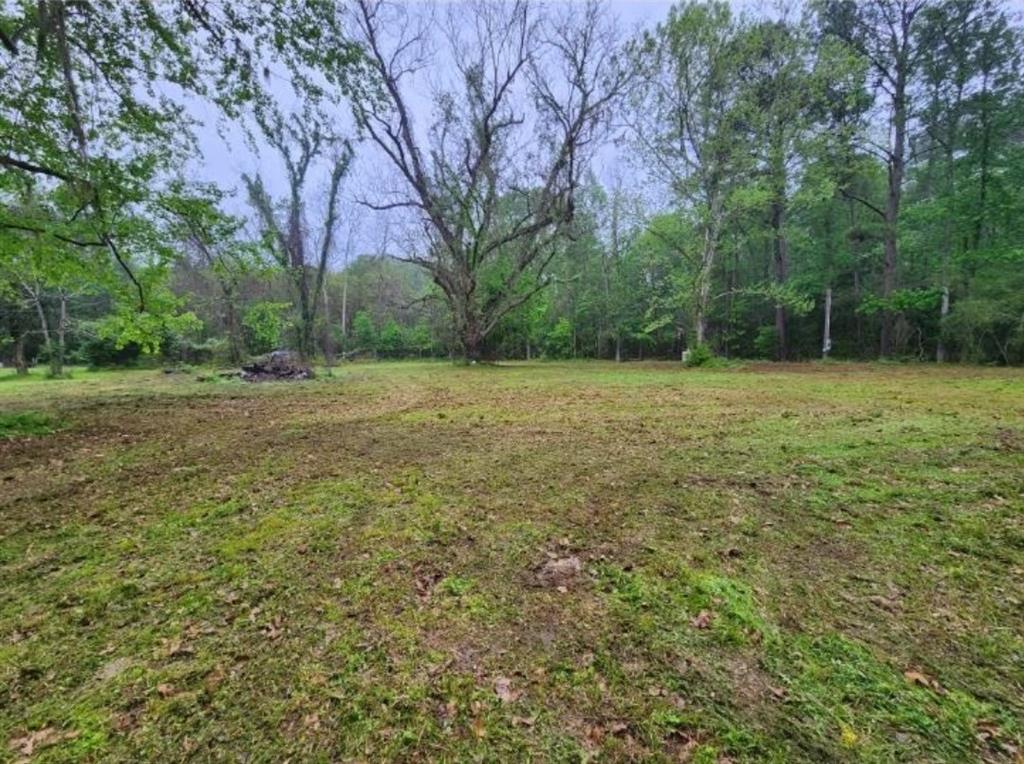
[{"xmin": 0, "ymin": 0, "xmax": 1024, "ymax": 368}]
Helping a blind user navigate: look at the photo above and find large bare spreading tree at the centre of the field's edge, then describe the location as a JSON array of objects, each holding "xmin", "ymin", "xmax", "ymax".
[{"xmin": 354, "ymin": 0, "xmax": 631, "ymax": 360}]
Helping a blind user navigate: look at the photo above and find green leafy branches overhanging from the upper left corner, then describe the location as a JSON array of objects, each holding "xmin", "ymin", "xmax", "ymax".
[{"xmin": 0, "ymin": 0, "xmax": 359, "ymax": 346}]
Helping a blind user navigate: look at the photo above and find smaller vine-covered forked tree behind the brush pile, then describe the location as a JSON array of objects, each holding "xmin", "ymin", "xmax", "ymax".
[{"xmin": 243, "ymin": 114, "xmax": 352, "ymax": 358}]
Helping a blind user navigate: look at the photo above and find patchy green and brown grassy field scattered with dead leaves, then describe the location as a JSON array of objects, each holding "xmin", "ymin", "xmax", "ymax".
[{"xmin": 0, "ymin": 363, "xmax": 1024, "ymax": 762}]
